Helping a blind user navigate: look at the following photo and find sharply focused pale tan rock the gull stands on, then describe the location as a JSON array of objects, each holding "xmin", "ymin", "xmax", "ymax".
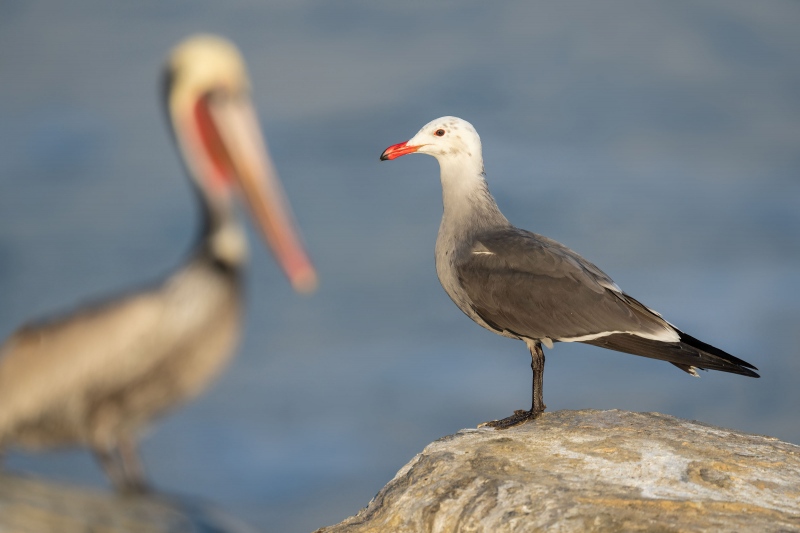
[{"xmin": 318, "ymin": 410, "xmax": 800, "ymax": 533}]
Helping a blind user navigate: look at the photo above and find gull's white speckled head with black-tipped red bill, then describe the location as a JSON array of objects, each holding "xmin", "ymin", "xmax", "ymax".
[{"xmin": 381, "ymin": 117, "xmax": 483, "ymax": 167}]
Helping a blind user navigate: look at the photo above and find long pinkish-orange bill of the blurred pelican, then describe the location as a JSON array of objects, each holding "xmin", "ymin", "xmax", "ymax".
[{"xmin": 206, "ymin": 96, "xmax": 317, "ymax": 293}]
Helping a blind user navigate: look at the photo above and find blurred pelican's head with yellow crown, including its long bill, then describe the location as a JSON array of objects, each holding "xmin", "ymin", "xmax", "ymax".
[{"xmin": 165, "ymin": 35, "xmax": 317, "ymax": 292}]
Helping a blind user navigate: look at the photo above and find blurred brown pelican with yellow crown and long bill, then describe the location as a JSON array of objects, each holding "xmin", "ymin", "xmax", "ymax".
[{"xmin": 0, "ymin": 36, "xmax": 316, "ymax": 491}]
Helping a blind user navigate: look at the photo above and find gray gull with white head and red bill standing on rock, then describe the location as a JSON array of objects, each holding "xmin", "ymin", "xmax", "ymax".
[{"xmin": 381, "ymin": 117, "xmax": 758, "ymax": 428}]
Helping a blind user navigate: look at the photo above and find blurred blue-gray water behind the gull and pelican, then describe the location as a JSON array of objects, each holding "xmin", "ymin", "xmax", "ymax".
[{"xmin": 0, "ymin": 0, "xmax": 800, "ymax": 532}]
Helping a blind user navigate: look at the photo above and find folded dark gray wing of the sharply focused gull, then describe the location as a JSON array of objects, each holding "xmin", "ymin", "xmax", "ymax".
[{"xmin": 455, "ymin": 228, "xmax": 678, "ymax": 341}]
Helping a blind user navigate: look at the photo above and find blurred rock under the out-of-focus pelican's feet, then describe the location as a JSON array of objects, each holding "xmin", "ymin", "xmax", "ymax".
[{"xmin": 0, "ymin": 475, "xmax": 254, "ymax": 533}]
